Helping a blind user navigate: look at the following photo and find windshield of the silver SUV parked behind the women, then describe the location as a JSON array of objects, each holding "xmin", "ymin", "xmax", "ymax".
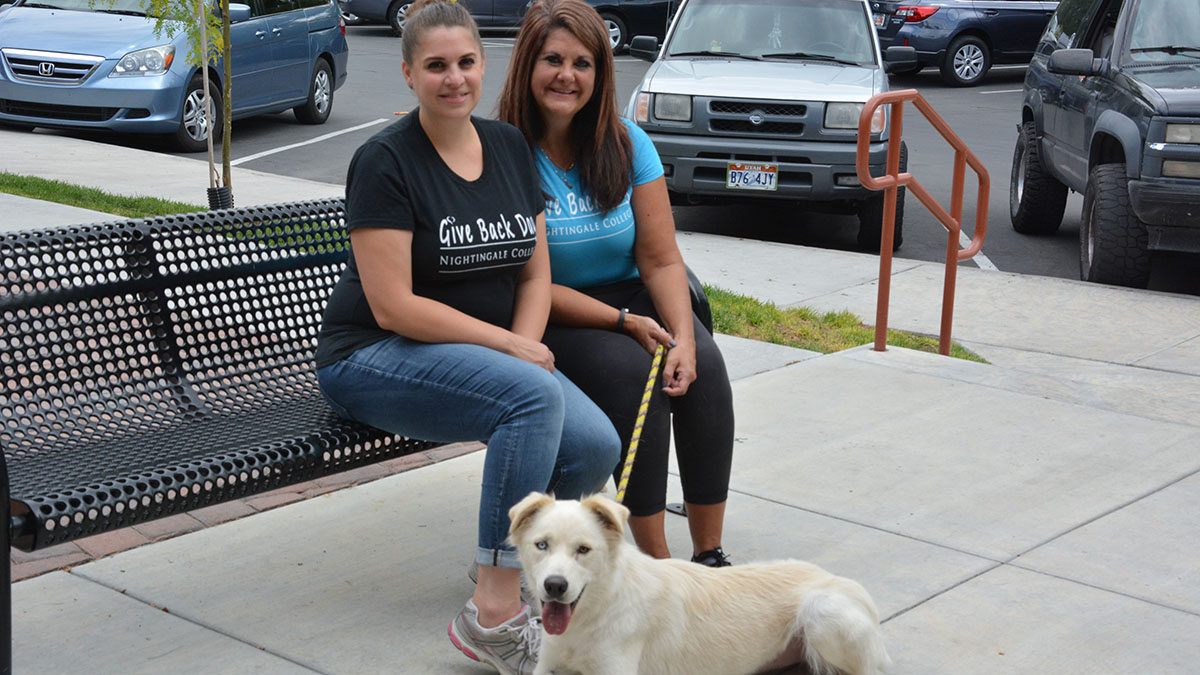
[{"xmin": 667, "ymin": 0, "xmax": 873, "ymax": 64}]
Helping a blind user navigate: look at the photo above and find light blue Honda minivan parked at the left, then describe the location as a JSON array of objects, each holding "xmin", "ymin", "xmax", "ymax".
[{"xmin": 0, "ymin": 0, "xmax": 348, "ymax": 151}]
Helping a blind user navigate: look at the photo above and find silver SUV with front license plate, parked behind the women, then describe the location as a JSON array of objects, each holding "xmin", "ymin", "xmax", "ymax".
[{"xmin": 625, "ymin": 0, "xmax": 916, "ymax": 250}]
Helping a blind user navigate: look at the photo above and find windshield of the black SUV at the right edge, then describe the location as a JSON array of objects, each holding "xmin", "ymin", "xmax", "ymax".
[{"xmin": 1129, "ymin": 0, "xmax": 1200, "ymax": 64}]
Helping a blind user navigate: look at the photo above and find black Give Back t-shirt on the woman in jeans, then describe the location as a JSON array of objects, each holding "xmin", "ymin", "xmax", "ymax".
[{"xmin": 317, "ymin": 110, "xmax": 546, "ymax": 368}]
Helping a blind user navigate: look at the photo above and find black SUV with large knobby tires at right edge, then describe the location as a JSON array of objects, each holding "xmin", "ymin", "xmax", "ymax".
[{"xmin": 1008, "ymin": 0, "xmax": 1200, "ymax": 288}]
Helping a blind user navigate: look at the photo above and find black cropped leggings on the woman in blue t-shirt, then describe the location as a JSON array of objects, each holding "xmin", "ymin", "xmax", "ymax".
[{"xmin": 542, "ymin": 280, "xmax": 733, "ymax": 515}]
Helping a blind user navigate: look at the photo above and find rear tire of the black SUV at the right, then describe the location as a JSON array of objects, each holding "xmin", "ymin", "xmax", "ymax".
[{"xmin": 1008, "ymin": 120, "xmax": 1067, "ymax": 234}]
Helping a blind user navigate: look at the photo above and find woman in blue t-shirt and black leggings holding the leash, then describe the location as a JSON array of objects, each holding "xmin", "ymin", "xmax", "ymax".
[{"xmin": 499, "ymin": 0, "xmax": 733, "ymax": 567}]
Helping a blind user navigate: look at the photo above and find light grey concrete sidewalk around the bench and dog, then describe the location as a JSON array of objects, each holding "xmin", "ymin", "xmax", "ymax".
[{"xmin": 7, "ymin": 131, "xmax": 1200, "ymax": 675}]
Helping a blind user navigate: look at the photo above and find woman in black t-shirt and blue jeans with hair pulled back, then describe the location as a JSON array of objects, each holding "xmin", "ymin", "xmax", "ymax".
[{"xmin": 317, "ymin": 1, "xmax": 620, "ymax": 673}]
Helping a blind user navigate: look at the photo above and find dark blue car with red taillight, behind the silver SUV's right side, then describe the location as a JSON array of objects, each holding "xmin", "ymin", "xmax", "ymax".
[{"xmin": 871, "ymin": 0, "xmax": 1058, "ymax": 86}]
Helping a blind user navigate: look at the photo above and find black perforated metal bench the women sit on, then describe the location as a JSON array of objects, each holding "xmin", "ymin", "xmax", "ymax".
[{"xmin": 0, "ymin": 199, "xmax": 433, "ymax": 673}]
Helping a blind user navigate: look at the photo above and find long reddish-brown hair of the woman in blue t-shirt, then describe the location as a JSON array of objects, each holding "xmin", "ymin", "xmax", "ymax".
[{"xmin": 499, "ymin": 0, "xmax": 634, "ymax": 211}]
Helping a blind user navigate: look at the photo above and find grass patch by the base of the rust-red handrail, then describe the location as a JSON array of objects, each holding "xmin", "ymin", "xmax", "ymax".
[{"xmin": 704, "ymin": 286, "xmax": 988, "ymax": 363}]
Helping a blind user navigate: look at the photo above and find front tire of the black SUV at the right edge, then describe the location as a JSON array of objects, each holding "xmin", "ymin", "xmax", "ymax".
[{"xmin": 1079, "ymin": 163, "xmax": 1150, "ymax": 288}]
